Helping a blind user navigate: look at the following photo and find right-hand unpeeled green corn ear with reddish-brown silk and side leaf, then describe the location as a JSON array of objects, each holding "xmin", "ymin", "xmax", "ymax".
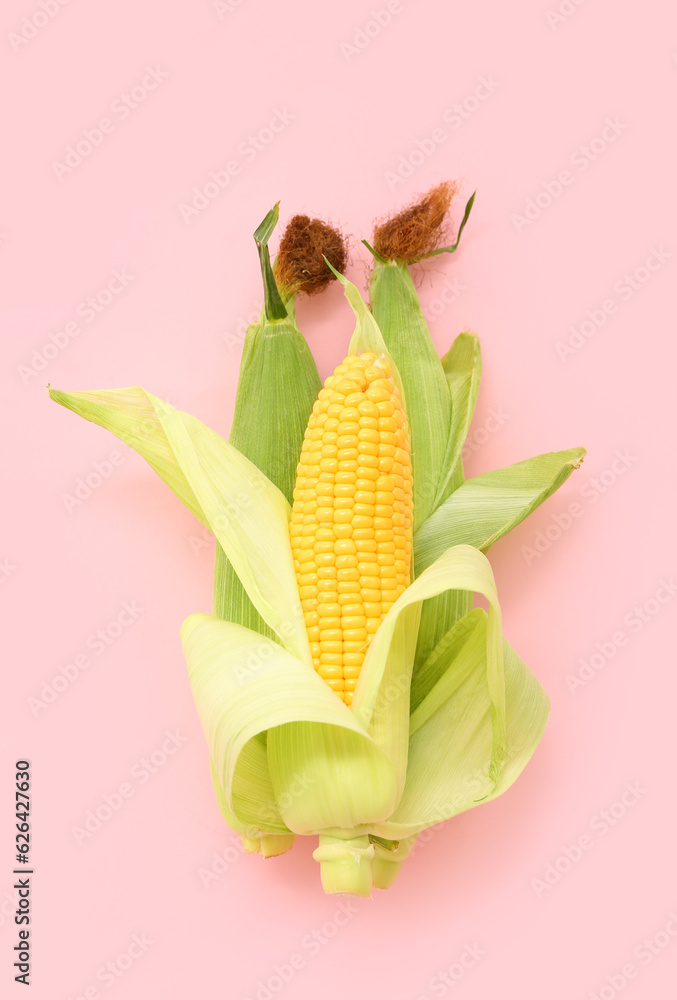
[{"xmin": 364, "ymin": 184, "xmax": 585, "ymax": 670}]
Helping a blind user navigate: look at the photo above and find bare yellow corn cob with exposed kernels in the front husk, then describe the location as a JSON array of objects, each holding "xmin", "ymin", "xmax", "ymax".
[{"xmin": 290, "ymin": 354, "xmax": 412, "ymax": 705}]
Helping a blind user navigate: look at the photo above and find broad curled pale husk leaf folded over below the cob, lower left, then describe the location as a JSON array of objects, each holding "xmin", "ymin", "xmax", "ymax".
[{"xmin": 182, "ymin": 615, "xmax": 396, "ymax": 833}]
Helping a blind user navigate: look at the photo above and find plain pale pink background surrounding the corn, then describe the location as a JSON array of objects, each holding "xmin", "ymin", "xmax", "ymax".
[{"xmin": 0, "ymin": 0, "xmax": 677, "ymax": 1000}]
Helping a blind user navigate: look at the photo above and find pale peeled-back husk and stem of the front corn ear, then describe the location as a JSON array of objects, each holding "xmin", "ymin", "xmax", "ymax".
[{"xmin": 51, "ymin": 268, "xmax": 560, "ymax": 896}]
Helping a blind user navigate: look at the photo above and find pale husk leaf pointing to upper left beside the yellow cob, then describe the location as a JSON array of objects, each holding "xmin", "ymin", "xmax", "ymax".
[{"xmin": 50, "ymin": 386, "xmax": 311, "ymax": 663}]
